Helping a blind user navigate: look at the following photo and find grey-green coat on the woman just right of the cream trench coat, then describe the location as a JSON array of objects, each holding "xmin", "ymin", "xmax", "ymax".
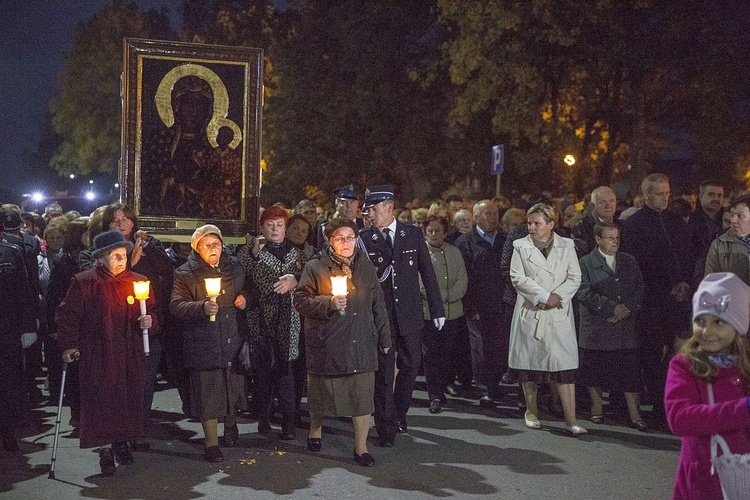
[{"xmin": 576, "ymin": 248, "xmax": 645, "ymax": 351}]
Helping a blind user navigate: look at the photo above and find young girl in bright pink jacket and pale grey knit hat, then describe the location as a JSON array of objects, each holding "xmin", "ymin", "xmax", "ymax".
[{"xmin": 664, "ymin": 273, "xmax": 750, "ymax": 500}]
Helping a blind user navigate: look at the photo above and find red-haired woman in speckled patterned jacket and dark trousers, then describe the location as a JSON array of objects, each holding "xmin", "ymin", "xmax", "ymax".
[{"xmin": 238, "ymin": 205, "xmax": 306, "ymax": 441}]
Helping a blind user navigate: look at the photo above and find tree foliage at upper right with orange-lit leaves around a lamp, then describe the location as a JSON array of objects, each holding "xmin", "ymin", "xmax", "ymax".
[{"xmin": 438, "ymin": 0, "xmax": 748, "ymax": 191}]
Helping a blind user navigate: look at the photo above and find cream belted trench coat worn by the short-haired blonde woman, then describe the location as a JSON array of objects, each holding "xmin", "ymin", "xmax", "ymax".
[{"xmin": 508, "ymin": 233, "xmax": 581, "ymax": 372}]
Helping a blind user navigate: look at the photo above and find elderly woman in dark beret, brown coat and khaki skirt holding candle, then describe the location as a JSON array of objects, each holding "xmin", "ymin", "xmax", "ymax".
[{"xmin": 294, "ymin": 218, "xmax": 391, "ymax": 467}]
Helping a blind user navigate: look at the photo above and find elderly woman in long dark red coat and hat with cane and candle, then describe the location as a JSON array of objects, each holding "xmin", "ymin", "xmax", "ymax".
[{"xmin": 56, "ymin": 231, "xmax": 156, "ymax": 476}]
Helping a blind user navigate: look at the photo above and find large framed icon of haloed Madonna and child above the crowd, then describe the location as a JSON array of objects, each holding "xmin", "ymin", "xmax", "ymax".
[{"xmin": 120, "ymin": 38, "xmax": 263, "ymax": 241}]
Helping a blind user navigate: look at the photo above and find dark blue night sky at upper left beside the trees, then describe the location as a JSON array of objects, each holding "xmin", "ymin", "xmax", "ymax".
[{"xmin": 0, "ymin": 0, "xmax": 182, "ymax": 203}]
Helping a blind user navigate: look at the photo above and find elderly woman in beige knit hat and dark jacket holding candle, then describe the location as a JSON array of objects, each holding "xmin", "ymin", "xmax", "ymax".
[{"xmin": 169, "ymin": 224, "xmax": 247, "ymax": 463}]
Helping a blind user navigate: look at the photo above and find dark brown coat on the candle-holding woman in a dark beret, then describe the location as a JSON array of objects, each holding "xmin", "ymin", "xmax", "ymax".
[{"xmin": 294, "ymin": 249, "xmax": 391, "ymax": 376}]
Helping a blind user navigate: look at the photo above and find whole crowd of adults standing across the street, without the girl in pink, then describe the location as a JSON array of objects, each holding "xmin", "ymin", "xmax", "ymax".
[{"xmin": 0, "ymin": 174, "xmax": 750, "ymax": 494}]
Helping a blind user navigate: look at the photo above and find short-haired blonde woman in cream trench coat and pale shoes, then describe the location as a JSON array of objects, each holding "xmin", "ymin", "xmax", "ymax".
[{"xmin": 508, "ymin": 203, "xmax": 586, "ymax": 435}]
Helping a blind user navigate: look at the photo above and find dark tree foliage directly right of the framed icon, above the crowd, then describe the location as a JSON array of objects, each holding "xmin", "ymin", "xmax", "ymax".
[{"xmin": 265, "ymin": 0, "xmax": 462, "ymax": 205}]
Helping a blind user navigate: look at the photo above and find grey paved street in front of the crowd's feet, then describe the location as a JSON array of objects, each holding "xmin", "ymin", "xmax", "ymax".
[{"xmin": 0, "ymin": 378, "xmax": 680, "ymax": 500}]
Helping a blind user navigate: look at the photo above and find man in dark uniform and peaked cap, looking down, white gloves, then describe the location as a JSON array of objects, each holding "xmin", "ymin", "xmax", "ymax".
[{"xmin": 360, "ymin": 185, "xmax": 445, "ymax": 447}]
